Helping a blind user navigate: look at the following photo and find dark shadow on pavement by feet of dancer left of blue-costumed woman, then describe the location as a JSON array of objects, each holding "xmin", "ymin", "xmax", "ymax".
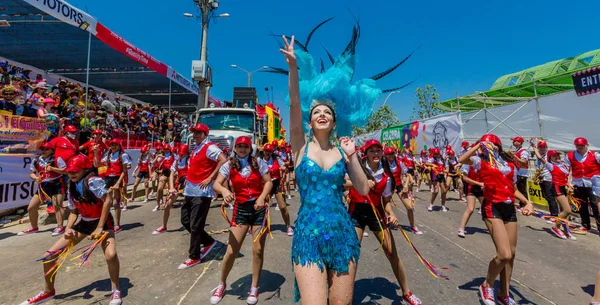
[{"xmin": 227, "ymin": 269, "xmax": 285, "ymax": 301}]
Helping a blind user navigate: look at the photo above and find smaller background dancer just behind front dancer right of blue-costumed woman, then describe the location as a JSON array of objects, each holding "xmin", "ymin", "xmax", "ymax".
[{"xmin": 382, "ymin": 147, "xmax": 423, "ymax": 235}]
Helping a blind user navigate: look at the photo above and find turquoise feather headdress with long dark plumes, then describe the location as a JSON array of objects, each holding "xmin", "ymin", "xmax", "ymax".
[{"xmin": 266, "ymin": 18, "xmax": 416, "ymax": 136}]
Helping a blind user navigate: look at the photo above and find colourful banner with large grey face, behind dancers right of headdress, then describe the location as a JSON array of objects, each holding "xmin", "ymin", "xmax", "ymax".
[{"xmin": 380, "ymin": 113, "xmax": 462, "ymax": 155}]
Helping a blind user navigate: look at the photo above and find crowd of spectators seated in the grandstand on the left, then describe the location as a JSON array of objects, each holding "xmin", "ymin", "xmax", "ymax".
[{"xmin": 0, "ymin": 61, "xmax": 190, "ymax": 143}]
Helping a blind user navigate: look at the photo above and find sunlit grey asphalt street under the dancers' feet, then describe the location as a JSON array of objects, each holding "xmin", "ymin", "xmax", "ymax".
[{"xmin": 0, "ymin": 191, "xmax": 600, "ymax": 305}]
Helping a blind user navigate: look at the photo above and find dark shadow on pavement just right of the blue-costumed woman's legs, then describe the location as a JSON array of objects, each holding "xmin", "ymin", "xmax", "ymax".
[{"xmin": 352, "ymin": 277, "xmax": 403, "ymax": 305}]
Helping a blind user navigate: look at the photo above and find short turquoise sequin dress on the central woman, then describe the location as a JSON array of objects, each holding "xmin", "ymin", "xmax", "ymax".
[{"xmin": 292, "ymin": 143, "xmax": 360, "ymax": 302}]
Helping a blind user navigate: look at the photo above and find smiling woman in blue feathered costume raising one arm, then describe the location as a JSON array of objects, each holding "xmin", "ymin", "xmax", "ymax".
[{"xmin": 280, "ymin": 36, "xmax": 372, "ymax": 305}]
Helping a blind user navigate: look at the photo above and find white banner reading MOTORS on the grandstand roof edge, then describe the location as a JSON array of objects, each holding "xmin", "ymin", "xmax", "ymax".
[{"xmin": 23, "ymin": 0, "xmax": 98, "ymax": 35}]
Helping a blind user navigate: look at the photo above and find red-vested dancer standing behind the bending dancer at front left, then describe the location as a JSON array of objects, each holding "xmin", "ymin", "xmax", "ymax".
[{"xmin": 94, "ymin": 140, "xmax": 131, "ymax": 233}]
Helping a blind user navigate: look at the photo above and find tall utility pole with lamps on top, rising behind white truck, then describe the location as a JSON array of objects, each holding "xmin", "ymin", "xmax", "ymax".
[{"xmin": 183, "ymin": 0, "xmax": 229, "ymax": 123}]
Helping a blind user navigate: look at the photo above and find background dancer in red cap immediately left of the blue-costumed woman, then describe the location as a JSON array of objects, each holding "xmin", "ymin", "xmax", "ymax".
[{"xmin": 263, "ymin": 142, "xmax": 294, "ymax": 236}]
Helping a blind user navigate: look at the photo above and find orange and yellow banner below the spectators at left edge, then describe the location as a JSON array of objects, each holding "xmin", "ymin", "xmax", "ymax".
[{"xmin": 0, "ymin": 114, "xmax": 48, "ymax": 153}]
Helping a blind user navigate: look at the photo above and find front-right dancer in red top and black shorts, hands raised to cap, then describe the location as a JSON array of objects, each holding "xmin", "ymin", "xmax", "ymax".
[{"xmin": 459, "ymin": 134, "xmax": 533, "ymax": 305}]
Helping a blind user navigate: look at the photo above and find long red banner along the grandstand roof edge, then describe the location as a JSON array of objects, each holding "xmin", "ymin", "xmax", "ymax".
[{"xmin": 96, "ymin": 22, "xmax": 168, "ymax": 76}]
